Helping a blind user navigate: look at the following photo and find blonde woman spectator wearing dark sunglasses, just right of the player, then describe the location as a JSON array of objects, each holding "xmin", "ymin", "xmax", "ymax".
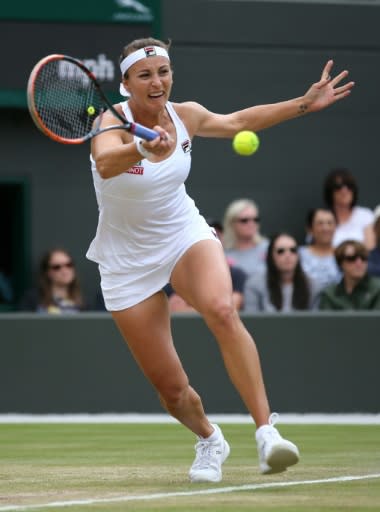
[{"xmin": 223, "ymin": 199, "xmax": 268, "ymax": 276}]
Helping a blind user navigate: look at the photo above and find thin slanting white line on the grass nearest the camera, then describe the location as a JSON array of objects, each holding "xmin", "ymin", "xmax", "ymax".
[{"xmin": 0, "ymin": 473, "xmax": 380, "ymax": 512}]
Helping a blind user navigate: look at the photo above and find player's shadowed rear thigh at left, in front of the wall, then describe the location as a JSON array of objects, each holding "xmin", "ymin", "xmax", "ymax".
[{"xmin": 112, "ymin": 292, "xmax": 187, "ymax": 387}]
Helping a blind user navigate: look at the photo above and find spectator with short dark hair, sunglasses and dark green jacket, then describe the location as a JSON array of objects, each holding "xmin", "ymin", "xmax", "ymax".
[{"xmin": 319, "ymin": 240, "xmax": 380, "ymax": 310}]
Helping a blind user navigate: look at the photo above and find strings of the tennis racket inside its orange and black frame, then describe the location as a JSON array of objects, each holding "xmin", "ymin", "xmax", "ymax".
[{"xmin": 34, "ymin": 59, "xmax": 103, "ymax": 140}]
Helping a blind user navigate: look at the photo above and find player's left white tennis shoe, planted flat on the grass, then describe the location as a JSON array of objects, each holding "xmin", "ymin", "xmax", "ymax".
[{"xmin": 189, "ymin": 425, "xmax": 230, "ymax": 482}]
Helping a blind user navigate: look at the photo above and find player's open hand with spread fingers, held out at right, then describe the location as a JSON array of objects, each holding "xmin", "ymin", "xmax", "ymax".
[{"xmin": 303, "ymin": 60, "xmax": 355, "ymax": 112}]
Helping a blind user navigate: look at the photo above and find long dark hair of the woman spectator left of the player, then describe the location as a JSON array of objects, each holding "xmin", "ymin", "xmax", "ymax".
[{"xmin": 38, "ymin": 247, "xmax": 83, "ymax": 307}]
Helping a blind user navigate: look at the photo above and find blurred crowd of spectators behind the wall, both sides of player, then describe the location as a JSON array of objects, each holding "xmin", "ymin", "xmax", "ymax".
[{"xmin": 0, "ymin": 168, "xmax": 380, "ymax": 313}]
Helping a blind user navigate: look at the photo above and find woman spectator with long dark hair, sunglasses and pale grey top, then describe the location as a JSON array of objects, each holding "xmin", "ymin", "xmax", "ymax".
[{"xmin": 244, "ymin": 233, "xmax": 318, "ymax": 313}]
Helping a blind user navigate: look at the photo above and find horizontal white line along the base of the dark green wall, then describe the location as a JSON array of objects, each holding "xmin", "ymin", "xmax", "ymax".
[{"xmin": 0, "ymin": 413, "xmax": 380, "ymax": 425}]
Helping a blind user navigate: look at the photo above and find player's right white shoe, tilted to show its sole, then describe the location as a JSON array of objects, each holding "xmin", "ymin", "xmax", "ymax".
[{"xmin": 256, "ymin": 413, "xmax": 299, "ymax": 475}]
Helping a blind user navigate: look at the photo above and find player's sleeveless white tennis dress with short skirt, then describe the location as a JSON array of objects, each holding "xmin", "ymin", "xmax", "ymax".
[{"xmin": 86, "ymin": 102, "xmax": 217, "ymax": 311}]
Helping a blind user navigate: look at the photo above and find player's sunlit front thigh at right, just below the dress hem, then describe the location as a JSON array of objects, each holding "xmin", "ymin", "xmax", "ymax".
[{"xmin": 171, "ymin": 240, "xmax": 232, "ymax": 313}]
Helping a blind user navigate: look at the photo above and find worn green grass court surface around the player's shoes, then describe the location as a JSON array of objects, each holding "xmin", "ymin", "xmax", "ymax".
[{"xmin": 0, "ymin": 424, "xmax": 380, "ymax": 512}]
